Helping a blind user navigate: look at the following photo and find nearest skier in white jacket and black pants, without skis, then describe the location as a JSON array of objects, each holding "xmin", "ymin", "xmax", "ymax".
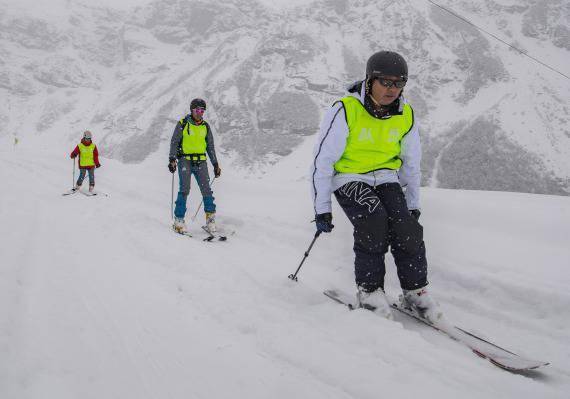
[{"xmin": 311, "ymin": 51, "xmax": 442, "ymax": 323}]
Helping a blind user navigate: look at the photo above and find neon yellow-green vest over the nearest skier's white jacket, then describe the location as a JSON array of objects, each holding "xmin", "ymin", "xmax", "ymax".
[{"xmin": 334, "ymin": 96, "xmax": 414, "ymax": 173}]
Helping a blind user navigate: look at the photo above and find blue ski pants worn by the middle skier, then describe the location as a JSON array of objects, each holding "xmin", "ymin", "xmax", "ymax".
[{"xmin": 174, "ymin": 158, "xmax": 216, "ymax": 219}]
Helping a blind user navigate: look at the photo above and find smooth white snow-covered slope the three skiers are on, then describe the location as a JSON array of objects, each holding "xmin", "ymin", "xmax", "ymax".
[{"xmin": 0, "ymin": 139, "xmax": 570, "ymax": 399}]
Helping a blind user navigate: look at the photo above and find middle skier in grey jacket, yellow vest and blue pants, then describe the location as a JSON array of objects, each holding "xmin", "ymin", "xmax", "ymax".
[{"xmin": 168, "ymin": 98, "xmax": 222, "ymax": 233}]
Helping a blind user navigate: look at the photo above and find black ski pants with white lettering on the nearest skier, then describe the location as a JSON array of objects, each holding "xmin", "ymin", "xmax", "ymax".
[{"xmin": 335, "ymin": 182, "xmax": 427, "ymax": 291}]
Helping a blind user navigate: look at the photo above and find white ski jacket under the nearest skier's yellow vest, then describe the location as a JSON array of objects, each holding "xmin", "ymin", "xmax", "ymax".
[{"xmin": 311, "ymin": 84, "xmax": 422, "ymax": 215}]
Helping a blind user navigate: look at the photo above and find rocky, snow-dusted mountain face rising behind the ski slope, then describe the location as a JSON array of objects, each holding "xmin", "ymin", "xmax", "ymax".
[{"xmin": 0, "ymin": 0, "xmax": 570, "ymax": 195}]
